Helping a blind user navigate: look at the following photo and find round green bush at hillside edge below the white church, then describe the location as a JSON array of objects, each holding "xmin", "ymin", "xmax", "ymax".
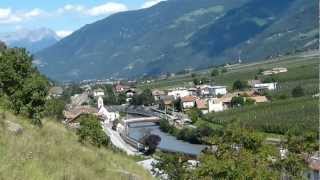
[{"xmin": 78, "ymin": 115, "xmax": 109, "ymax": 147}]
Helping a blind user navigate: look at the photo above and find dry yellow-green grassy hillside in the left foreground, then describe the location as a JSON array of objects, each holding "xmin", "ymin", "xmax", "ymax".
[{"xmin": 0, "ymin": 111, "xmax": 152, "ymax": 180}]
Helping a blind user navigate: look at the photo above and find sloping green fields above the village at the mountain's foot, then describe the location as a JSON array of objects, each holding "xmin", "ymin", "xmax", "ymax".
[{"xmin": 138, "ymin": 54, "xmax": 319, "ymax": 95}]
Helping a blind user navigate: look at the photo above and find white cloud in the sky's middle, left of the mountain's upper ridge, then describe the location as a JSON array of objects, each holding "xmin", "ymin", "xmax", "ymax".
[{"xmin": 87, "ymin": 2, "xmax": 128, "ymax": 16}]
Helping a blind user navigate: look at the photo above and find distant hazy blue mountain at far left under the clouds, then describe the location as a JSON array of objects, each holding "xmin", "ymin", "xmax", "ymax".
[{"xmin": 0, "ymin": 28, "xmax": 60, "ymax": 53}]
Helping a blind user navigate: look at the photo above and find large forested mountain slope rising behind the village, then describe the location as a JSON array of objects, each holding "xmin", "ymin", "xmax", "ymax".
[{"xmin": 36, "ymin": 0, "xmax": 319, "ymax": 80}]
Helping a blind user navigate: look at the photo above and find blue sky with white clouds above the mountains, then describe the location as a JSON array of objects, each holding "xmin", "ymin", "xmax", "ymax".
[{"xmin": 0, "ymin": 0, "xmax": 164, "ymax": 37}]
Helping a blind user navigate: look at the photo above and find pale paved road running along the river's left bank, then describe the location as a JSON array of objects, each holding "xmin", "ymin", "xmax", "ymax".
[{"xmin": 101, "ymin": 123, "xmax": 140, "ymax": 155}]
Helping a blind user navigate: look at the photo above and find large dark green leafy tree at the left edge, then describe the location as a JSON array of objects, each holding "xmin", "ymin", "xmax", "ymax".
[{"xmin": 0, "ymin": 49, "xmax": 49, "ymax": 124}]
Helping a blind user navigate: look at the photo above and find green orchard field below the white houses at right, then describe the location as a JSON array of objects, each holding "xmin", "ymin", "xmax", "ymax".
[{"xmin": 207, "ymin": 97, "xmax": 319, "ymax": 134}]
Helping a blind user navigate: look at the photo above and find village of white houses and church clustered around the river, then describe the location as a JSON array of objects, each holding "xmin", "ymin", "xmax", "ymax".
[{"xmin": 51, "ymin": 65, "xmax": 287, "ymax": 154}]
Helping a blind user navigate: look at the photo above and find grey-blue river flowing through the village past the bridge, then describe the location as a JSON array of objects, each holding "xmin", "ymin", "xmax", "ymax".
[{"xmin": 129, "ymin": 123, "xmax": 206, "ymax": 156}]
